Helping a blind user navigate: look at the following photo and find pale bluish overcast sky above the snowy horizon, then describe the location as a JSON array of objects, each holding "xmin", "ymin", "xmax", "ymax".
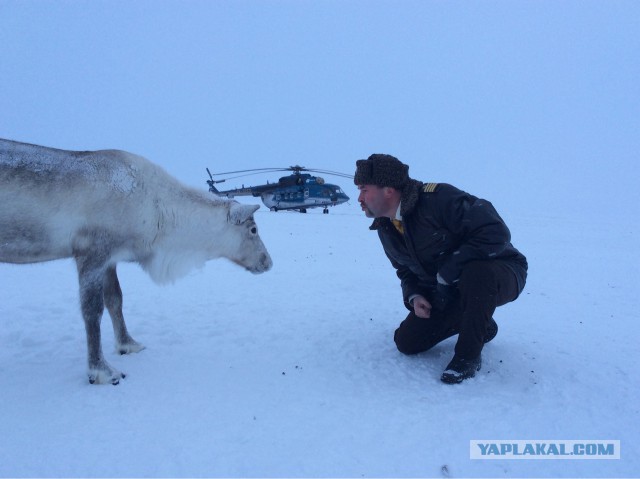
[{"xmin": 0, "ymin": 0, "xmax": 640, "ymax": 215}]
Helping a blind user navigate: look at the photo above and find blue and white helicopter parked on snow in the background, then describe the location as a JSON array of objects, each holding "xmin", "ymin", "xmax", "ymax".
[{"xmin": 207, "ymin": 165, "xmax": 353, "ymax": 214}]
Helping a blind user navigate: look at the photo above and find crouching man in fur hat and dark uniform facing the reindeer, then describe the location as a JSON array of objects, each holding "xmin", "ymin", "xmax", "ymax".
[{"xmin": 354, "ymin": 154, "xmax": 527, "ymax": 384}]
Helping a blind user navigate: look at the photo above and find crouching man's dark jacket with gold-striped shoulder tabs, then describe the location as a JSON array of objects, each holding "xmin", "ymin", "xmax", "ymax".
[{"xmin": 370, "ymin": 180, "xmax": 527, "ymax": 307}]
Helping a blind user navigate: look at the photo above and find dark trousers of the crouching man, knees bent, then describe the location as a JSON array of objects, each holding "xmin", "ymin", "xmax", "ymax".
[{"xmin": 394, "ymin": 260, "xmax": 521, "ymax": 359}]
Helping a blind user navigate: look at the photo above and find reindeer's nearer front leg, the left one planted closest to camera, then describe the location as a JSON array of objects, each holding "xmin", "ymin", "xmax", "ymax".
[{"xmin": 76, "ymin": 254, "xmax": 124, "ymax": 385}]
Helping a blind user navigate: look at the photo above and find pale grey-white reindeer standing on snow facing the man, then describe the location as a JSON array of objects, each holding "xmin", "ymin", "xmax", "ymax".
[{"xmin": 0, "ymin": 139, "xmax": 272, "ymax": 385}]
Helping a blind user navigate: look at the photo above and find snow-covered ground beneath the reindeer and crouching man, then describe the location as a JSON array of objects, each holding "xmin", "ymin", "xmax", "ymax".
[{"xmin": 0, "ymin": 197, "xmax": 640, "ymax": 477}]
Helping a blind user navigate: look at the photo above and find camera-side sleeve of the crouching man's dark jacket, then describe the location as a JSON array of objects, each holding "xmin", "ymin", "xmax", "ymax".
[{"xmin": 434, "ymin": 185, "xmax": 511, "ymax": 284}]
